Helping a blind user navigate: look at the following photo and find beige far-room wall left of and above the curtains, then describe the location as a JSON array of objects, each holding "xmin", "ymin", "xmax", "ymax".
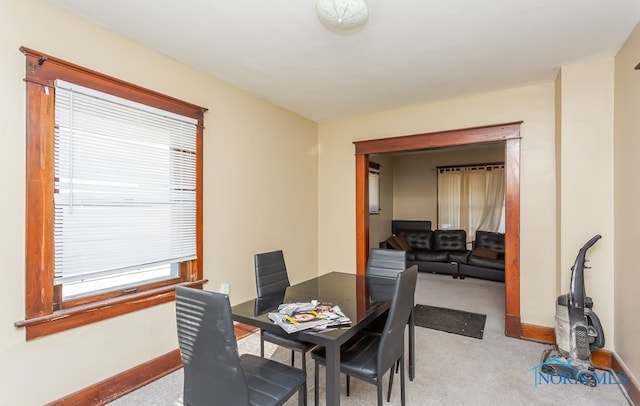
[{"xmin": 393, "ymin": 144, "xmax": 504, "ymax": 224}]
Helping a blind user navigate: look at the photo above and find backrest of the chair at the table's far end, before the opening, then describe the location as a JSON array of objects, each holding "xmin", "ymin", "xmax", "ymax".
[{"xmin": 366, "ymin": 248, "xmax": 407, "ymax": 302}]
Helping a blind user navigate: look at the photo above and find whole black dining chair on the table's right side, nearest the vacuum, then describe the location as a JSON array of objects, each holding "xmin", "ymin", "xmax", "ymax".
[{"xmin": 311, "ymin": 265, "xmax": 418, "ymax": 406}]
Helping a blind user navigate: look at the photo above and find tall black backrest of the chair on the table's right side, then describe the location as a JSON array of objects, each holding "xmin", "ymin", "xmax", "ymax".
[{"xmin": 378, "ymin": 265, "xmax": 418, "ymax": 374}]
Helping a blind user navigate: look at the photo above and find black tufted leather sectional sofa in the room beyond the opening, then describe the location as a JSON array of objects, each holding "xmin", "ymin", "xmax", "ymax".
[{"xmin": 380, "ymin": 220, "xmax": 504, "ymax": 282}]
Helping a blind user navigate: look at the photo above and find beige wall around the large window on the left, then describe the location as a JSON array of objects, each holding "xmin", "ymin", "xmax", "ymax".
[{"xmin": 0, "ymin": 0, "xmax": 318, "ymax": 405}]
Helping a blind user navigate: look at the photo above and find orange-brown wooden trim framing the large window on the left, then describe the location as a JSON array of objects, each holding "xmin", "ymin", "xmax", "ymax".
[{"xmin": 15, "ymin": 47, "xmax": 207, "ymax": 340}]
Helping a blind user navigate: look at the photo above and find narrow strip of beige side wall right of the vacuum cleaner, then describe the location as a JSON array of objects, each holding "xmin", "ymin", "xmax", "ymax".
[{"xmin": 613, "ymin": 21, "xmax": 640, "ymax": 389}]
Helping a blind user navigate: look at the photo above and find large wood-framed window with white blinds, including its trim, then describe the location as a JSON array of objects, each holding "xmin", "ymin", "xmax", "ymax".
[{"xmin": 16, "ymin": 48, "xmax": 206, "ymax": 339}]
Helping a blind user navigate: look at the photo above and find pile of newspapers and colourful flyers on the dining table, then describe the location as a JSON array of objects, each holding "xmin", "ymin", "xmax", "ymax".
[{"xmin": 268, "ymin": 300, "xmax": 351, "ymax": 334}]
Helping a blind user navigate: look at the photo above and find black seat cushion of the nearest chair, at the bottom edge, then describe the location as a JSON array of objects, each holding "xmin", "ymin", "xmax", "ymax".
[{"xmin": 240, "ymin": 354, "xmax": 306, "ymax": 406}]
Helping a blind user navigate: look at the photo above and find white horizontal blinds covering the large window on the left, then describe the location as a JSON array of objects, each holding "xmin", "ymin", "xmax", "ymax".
[{"xmin": 54, "ymin": 80, "xmax": 197, "ymax": 284}]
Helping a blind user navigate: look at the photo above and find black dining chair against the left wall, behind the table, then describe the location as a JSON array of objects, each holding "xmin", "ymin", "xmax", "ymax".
[{"xmin": 254, "ymin": 250, "xmax": 315, "ymax": 405}]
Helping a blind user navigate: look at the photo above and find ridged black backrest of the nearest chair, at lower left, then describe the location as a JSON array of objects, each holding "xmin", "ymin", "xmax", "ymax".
[{"xmin": 176, "ymin": 286, "xmax": 249, "ymax": 406}]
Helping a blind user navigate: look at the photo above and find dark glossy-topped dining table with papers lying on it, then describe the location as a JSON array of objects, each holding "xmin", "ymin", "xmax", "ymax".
[{"xmin": 231, "ymin": 272, "xmax": 390, "ymax": 406}]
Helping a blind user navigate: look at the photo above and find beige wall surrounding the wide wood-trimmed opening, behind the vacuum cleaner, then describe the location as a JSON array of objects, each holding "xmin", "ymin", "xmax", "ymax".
[{"xmin": 319, "ymin": 55, "xmax": 631, "ymax": 356}]
